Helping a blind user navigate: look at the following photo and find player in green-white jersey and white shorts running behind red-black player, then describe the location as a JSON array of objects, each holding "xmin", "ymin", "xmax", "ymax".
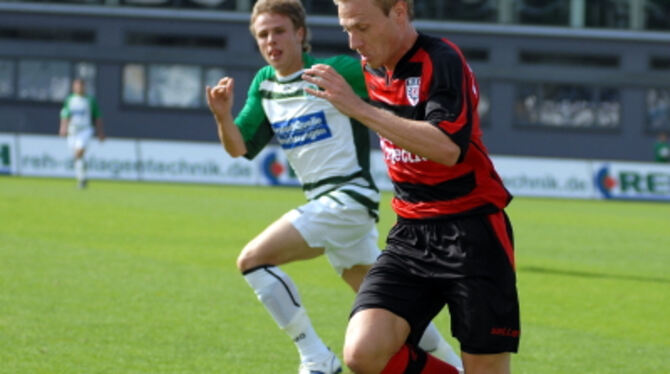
[{"xmin": 206, "ymin": 0, "xmax": 462, "ymax": 374}]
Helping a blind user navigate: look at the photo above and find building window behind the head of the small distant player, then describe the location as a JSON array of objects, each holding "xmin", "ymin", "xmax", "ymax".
[{"xmin": 17, "ymin": 59, "xmax": 96, "ymax": 102}]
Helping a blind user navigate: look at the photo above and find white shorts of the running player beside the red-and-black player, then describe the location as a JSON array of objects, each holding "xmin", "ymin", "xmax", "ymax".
[{"xmin": 284, "ymin": 191, "xmax": 381, "ymax": 275}]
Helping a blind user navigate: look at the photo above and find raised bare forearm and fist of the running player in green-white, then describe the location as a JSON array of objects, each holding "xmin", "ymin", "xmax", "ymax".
[{"xmin": 205, "ymin": 77, "xmax": 247, "ymax": 157}]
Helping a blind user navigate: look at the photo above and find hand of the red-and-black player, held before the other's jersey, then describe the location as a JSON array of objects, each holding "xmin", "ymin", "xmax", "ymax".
[{"xmin": 302, "ymin": 64, "xmax": 365, "ymax": 117}]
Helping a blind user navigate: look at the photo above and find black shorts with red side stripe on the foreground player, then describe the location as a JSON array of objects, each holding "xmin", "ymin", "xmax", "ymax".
[{"xmin": 352, "ymin": 212, "xmax": 520, "ymax": 354}]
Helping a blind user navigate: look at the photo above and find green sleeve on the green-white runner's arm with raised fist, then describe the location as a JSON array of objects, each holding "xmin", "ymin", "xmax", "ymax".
[{"xmin": 235, "ymin": 66, "xmax": 274, "ymax": 160}]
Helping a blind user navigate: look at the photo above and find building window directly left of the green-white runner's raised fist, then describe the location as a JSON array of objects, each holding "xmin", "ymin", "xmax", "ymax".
[{"xmin": 123, "ymin": 64, "xmax": 225, "ymax": 109}]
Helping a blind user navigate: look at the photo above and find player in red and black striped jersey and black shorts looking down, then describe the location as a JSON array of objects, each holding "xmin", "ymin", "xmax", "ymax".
[{"xmin": 304, "ymin": 0, "xmax": 520, "ymax": 374}]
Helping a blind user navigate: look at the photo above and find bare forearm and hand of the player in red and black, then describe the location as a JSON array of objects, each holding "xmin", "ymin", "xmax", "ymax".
[{"xmin": 303, "ymin": 65, "xmax": 461, "ymax": 166}]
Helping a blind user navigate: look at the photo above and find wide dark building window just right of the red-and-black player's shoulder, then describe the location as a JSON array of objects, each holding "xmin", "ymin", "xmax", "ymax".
[{"xmin": 515, "ymin": 83, "xmax": 621, "ymax": 129}]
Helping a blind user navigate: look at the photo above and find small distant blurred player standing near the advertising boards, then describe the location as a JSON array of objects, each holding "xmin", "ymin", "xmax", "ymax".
[{"xmin": 59, "ymin": 78, "xmax": 105, "ymax": 188}]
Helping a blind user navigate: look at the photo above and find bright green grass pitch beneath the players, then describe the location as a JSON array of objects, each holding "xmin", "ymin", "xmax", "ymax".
[{"xmin": 0, "ymin": 177, "xmax": 670, "ymax": 374}]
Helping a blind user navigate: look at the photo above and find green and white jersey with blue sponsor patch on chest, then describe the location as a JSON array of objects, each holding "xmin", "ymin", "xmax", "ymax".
[{"xmin": 235, "ymin": 54, "xmax": 379, "ymax": 216}]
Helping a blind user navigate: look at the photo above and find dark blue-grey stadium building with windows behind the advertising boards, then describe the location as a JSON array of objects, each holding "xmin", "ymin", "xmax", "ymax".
[{"xmin": 0, "ymin": 0, "xmax": 670, "ymax": 161}]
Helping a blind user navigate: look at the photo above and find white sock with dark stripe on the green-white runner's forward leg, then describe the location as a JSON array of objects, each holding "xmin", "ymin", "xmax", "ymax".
[{"xmin": 244, "ymin": 266, "xmax": 330, "ymax": 362}]
